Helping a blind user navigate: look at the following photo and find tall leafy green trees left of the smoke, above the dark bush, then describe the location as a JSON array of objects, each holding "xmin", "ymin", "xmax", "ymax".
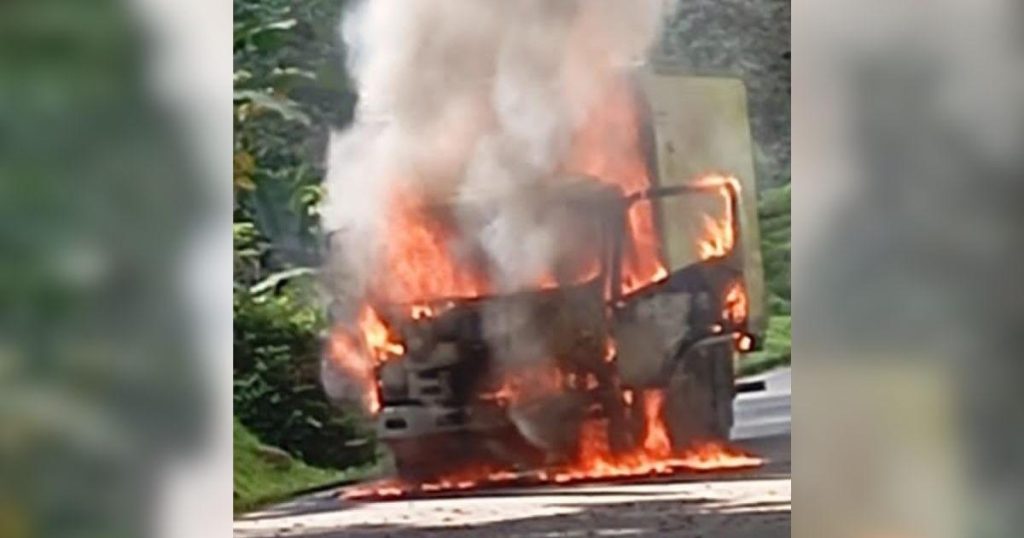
[{"xmin": 233, "ymin": 0, "xmax": 355, "ymax": 285}]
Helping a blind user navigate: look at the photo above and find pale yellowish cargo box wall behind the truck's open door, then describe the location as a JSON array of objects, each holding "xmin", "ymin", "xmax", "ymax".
[{"xmin": 639, "ymin": 71, "xmax": 765, "ymax": 332}]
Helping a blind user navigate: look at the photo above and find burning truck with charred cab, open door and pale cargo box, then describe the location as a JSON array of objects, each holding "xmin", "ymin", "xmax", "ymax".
[{"xmin": 325, "ymin": 68, "xmax": 764, "ymax": 487}]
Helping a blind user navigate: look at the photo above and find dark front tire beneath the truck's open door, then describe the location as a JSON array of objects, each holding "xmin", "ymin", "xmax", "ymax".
[{"xmin": 664, "ymin": 343, "xmax": 735, "ymax": 451}]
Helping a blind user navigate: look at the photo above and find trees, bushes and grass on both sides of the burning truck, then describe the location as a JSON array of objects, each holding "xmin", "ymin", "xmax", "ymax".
[{"xmin": 232, "ymin": 0, "xmax": 792, "ymax": 511}]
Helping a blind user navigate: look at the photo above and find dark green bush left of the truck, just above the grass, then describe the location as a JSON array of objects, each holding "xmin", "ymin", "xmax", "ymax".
[{"xmin": 234, "ymin": 280, "xmax": 375, "ymax": 468}]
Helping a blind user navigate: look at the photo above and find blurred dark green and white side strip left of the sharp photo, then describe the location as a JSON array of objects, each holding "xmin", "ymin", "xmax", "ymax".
[{"xmin": 0, "ymin": 0, "xmax": 231, "ymax": 538}]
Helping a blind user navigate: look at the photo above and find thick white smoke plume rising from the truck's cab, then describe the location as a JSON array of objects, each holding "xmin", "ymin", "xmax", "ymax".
[{"xmin": 323, "ymin": 0, "xmax": 663, "ymax": 297}]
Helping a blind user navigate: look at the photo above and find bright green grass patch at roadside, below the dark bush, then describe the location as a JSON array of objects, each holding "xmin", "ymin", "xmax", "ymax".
[{"xmin": 233, "ymin": 419, "xmax": 369, "ymax": 513}]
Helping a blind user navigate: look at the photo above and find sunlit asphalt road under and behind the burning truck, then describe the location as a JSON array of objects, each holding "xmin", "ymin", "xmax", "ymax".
[{"xmin": 234, "ymin": 369, "xmax": 791, "ymax": 538}]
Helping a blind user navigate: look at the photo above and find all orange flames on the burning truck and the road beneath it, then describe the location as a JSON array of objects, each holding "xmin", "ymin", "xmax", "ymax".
[{"xmin": 331, "ymin": 81, "xmax": 761, "ymax": 485}]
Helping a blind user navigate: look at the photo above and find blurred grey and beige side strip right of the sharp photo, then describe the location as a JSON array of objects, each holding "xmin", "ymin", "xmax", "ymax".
[{"xmin": 793, "ymin": 0, "xmax": 1024, "ymax": 537}]
